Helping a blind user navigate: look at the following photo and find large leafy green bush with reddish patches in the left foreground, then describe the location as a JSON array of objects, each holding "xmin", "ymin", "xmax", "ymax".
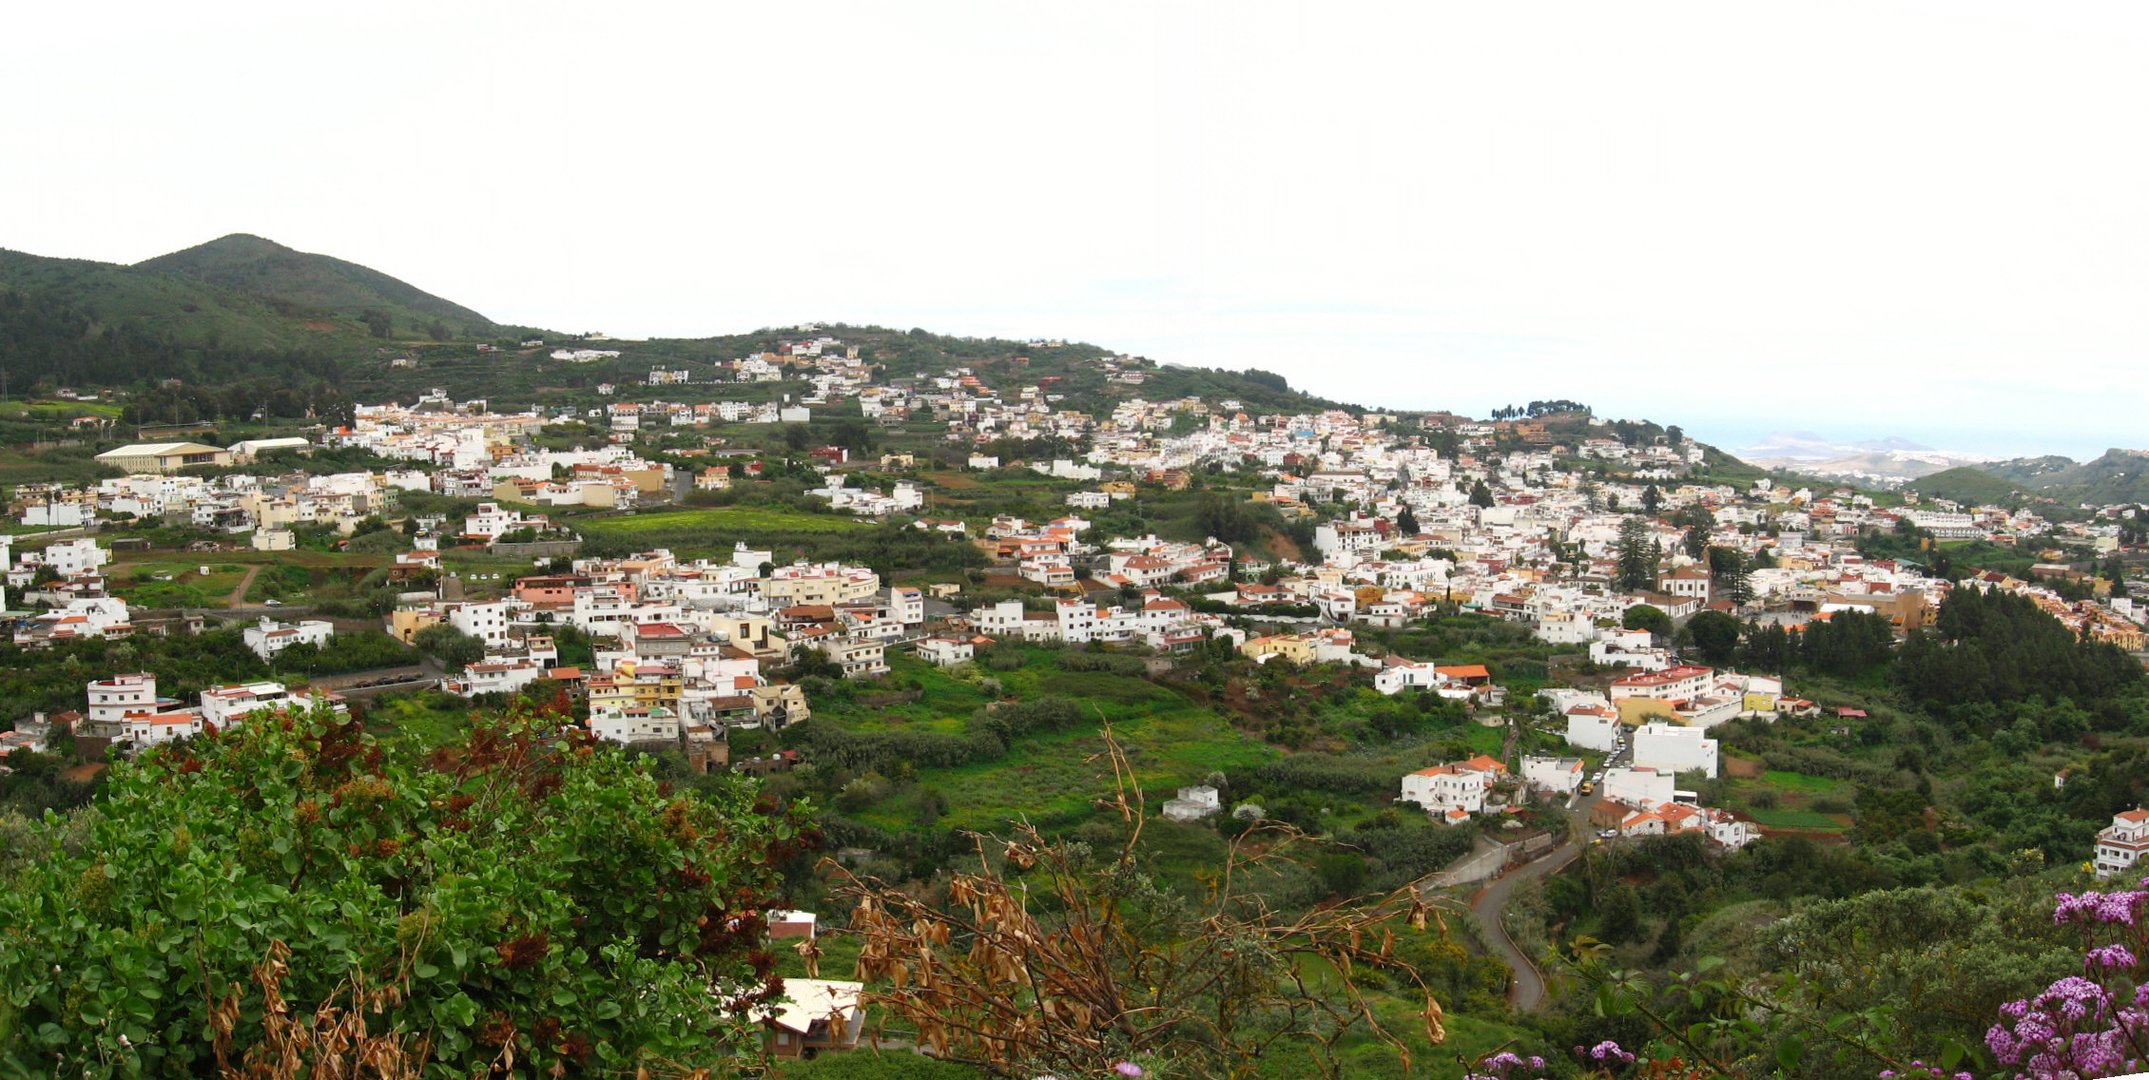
[{"xmin": 0, "ymin": 713, "xmax": 795, "ymax": 1076}]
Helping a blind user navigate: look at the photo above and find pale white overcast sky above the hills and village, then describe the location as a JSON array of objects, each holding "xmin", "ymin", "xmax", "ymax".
[{"xmin": 0, "ymin": 0, "xmax": 2149, "ymax": 457}]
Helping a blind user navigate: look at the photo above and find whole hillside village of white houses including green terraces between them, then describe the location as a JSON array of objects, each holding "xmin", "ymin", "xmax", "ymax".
[{"xmin": 0, "ymin": 333, "xmax": 2149, "ymax": 1073}]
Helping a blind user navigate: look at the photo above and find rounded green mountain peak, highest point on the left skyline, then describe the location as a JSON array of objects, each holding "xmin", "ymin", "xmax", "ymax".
[{"xmin": 133, "ymin": 232, "xmax": 496, "ymax": 339}]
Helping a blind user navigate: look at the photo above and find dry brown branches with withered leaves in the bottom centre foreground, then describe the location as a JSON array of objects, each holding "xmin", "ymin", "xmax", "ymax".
[{"xmin": 825, "ymin": 728, "xmax": 1446, "ymax": 1076}]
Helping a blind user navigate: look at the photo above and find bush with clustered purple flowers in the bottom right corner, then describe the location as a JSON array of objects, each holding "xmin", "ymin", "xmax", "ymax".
[{"xmin": 1986, "ymin": 878, "xmax": 2149, "ymax": 1080}]
